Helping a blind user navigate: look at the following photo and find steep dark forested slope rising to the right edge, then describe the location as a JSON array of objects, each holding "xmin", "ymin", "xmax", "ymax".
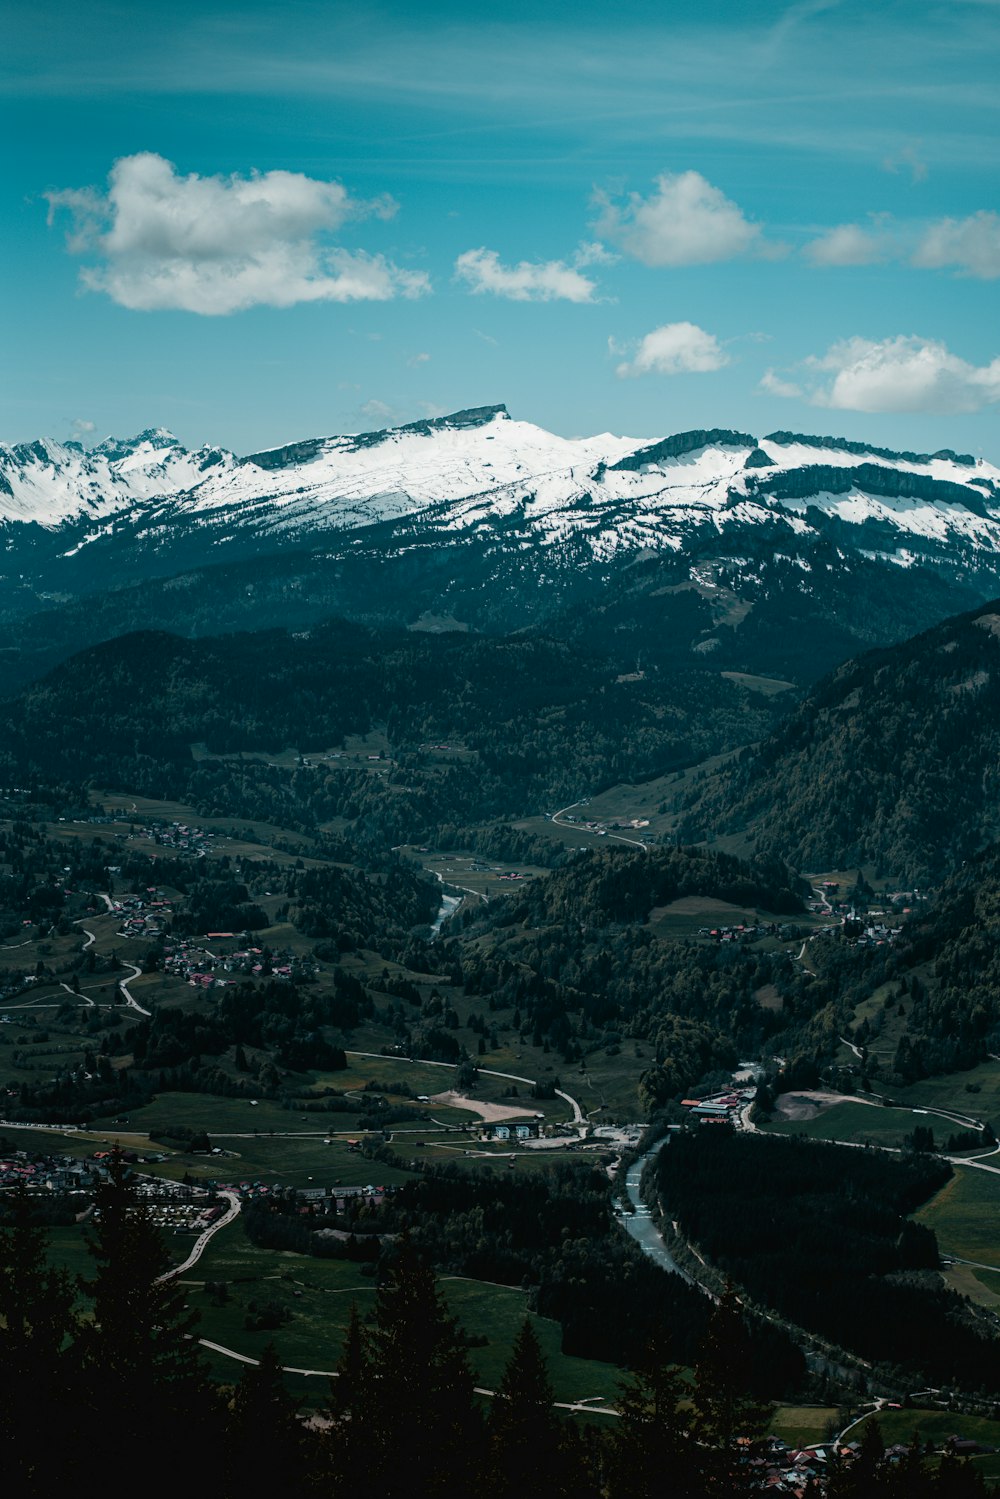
[{"xmin": 685, "ymin": 603, "xmax": 1000, "ymax": 883}]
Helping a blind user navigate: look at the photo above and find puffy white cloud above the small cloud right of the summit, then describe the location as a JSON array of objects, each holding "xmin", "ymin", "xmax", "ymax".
[{"xmin": 595, "ymin": 172, "xmax": 783, "ymax": 265}]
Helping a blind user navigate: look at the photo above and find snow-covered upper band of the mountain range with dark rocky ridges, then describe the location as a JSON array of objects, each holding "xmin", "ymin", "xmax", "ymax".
[{"xmin": 0, "ymin": 406, "xmax": 1000, "ymax": 565}]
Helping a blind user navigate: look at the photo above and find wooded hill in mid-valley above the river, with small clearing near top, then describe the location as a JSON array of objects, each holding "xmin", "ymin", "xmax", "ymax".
[{"xmin": 462, "ymin": 848, "xmax": 828, "ymax": 1112}]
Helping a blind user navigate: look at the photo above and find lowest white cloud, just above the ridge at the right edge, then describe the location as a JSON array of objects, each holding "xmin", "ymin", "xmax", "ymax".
[{"xmin": 762, "ymin": 334, "xmax": 1000, "ymax": 415}]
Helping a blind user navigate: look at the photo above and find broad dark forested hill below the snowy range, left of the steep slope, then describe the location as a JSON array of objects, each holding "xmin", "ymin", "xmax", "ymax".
[{"xmin": 0, "ymin": 621, "xmax": 777, "ymax": 847}]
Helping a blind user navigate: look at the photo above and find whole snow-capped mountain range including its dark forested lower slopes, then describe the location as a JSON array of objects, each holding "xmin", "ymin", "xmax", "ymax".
[{"xmin": 0, "ymin": 406, "xmax": 1000, "ymax": 692}]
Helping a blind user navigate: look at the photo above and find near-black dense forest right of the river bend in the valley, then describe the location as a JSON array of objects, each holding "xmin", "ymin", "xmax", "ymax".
[{"xmin": 658, "ymin": 1127, "xmax": 996, "ymax": 1390}]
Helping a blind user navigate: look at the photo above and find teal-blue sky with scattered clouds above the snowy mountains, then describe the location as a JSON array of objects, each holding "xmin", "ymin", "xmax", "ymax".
[{"xmin": 0, "ymin": 0, "xmax": 1000, "ymax": 460}]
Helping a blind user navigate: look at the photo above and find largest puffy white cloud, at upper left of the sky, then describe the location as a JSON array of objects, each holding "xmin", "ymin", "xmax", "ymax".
[{"xmin": 48, "ymin": 151, "xmax": 430, "ymax": 315}]
